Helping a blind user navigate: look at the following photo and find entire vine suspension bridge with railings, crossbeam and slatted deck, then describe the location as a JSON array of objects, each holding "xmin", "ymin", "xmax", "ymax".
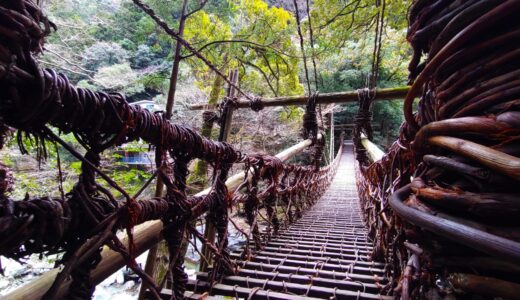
[{"xmin": 0, "ymin": 0, "xmax": 520, "ymax": 299}]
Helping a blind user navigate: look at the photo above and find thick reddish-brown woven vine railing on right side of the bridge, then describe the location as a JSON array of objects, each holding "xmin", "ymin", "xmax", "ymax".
[{"xmin": 355, "ymin": 0, "xmax": 520, "ymax": 299}]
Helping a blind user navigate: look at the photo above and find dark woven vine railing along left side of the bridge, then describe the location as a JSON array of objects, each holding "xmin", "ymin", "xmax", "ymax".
[{"xmin": 0, "ymin": 0, "xmax": 338, "ymax": 299}]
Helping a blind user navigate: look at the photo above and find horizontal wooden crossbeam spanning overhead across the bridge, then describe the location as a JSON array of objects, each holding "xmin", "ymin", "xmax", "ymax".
[{"xmin": 189, "ymin": 86, "xmax": 410, "ymax": 110}]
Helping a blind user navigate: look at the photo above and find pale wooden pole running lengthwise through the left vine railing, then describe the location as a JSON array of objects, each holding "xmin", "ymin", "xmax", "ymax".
[{"xmin": 2, "ymin": 136, "xmax": 320, "ymax": 300}]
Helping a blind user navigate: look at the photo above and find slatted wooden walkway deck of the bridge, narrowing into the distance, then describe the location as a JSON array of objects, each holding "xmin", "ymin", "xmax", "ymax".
[{"xmin": 183, "ymin": 144, "xmax": 393, "ymax": 299}]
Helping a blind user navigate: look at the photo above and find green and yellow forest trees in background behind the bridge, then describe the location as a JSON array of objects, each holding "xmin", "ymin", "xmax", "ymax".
[{"xmin": 2, "ymin": 0, "xmax": 411, "ymax": 197}]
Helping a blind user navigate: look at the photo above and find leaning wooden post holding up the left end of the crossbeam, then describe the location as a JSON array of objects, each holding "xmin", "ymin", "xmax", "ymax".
[{"xmin": 199, "ymin": 70, "xmax": 238, "ymax": 272}]
